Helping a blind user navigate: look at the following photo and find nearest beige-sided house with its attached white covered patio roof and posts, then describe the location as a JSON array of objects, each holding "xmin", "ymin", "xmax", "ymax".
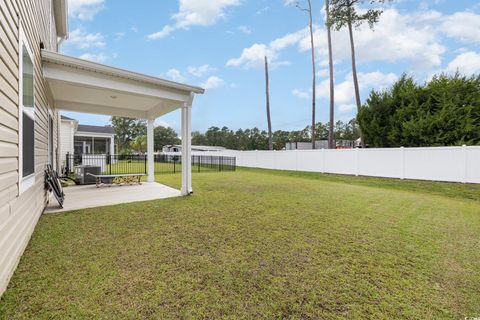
[{"xmin": 0, "ymin": 0, "xmax": 204, "ymax": 294}]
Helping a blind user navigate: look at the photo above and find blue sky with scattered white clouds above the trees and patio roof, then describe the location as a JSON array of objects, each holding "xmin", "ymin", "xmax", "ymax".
[{"xmin": 61, "ymin": 0, "xmax": 480, "ymax": 132}]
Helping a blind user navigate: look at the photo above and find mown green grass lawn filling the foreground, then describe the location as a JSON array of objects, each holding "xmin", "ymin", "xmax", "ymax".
[{"xmin": 0, "ymin": 169, "xmax": 480, "ymax": 319}]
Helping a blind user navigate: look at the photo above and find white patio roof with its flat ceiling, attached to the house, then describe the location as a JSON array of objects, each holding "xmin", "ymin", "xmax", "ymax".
[{"xmin": 42, "ymin": 50, "xmax": 204, "ymax": 119}]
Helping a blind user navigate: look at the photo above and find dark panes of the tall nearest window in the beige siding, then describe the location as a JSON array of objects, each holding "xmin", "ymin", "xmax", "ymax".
[{"xmin": 22, "ymin": 45, "xmax": 35, "ymax": 177}]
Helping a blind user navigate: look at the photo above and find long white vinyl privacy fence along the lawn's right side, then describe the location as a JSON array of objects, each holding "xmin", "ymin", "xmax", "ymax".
[{"xmin": 209, "ymin": 146, "xmax": 480, "ymax": 183}]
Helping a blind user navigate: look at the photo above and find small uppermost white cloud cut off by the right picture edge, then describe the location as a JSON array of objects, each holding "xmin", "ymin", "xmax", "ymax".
[{"xmin": 442, "ymin": 12, "xmax": 480, "ymax": 43}]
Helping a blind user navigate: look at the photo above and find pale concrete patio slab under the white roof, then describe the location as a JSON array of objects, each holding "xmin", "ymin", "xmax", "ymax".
[{"xmin": 45, "ymin": 182, "xmax": 181, "ymax": 213}]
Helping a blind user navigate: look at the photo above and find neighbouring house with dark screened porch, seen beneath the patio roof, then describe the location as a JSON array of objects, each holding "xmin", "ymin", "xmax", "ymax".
[{"xmin": 60, "ymin": 115, "xmax": 115, "ymax": 164}]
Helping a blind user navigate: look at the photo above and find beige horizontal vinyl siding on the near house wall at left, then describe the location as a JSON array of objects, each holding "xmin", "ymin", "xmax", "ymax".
[{"xmin": 0, "ymin": 0, "xmax": 58, "ymax": 295}]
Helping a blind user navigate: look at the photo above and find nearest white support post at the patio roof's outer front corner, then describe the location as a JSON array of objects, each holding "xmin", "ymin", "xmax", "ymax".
[{"xmin": 182, "ymin": 96, "xmax": 193, "ymax": 196}]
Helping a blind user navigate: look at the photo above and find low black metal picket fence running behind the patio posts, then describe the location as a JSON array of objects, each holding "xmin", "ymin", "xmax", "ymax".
[{"xmin": 63, "ymin": 154, "xmax": 236, "ymax": 175}]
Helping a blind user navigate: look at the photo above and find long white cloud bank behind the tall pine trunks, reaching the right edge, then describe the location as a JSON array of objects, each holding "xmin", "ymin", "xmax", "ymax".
[{"xmin": 227, "ymin": 8, "xmax": 480, "ymax": 74}]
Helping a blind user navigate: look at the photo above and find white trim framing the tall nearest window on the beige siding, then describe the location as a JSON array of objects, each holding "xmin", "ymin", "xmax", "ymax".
[{"xmin": 18, "ymin": 25, "xmax": 35, "ymax": 195}]
